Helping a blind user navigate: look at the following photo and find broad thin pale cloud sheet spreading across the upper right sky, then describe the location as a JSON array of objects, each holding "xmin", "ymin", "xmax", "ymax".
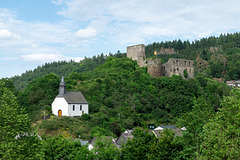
[{"xmin": 55, "ymin": 0, "xmax": 240, "ymax": 41}]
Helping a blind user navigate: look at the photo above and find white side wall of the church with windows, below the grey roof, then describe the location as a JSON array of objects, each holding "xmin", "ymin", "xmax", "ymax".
[{"xmin": 68, "ymin": 104, "xmax": 88, "ymax": 117}]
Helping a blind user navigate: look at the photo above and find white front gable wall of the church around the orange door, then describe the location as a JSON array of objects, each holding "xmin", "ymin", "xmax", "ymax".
[{"xmin": 52, "ymin": 97, "xmax": 68, "ymax": 116}]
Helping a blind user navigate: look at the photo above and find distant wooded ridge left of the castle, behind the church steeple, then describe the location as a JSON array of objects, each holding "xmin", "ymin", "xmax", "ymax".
[{"xmin": 11, "ymin": 51, "xmax": 126, "ymax": 90}]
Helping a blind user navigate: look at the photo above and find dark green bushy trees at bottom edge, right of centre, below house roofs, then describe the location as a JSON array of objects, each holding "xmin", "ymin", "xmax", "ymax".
[{"xmin": 121, "ymin": 128, "xmax": 183, "ymax": 160}]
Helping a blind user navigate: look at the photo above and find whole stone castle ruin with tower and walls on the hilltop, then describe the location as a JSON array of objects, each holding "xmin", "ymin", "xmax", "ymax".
[{"xmin": 127, "ymin": 44, "xmax": 194, "ymax": 79}]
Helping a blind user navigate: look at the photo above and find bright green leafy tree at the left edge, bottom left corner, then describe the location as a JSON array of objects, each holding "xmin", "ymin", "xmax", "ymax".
[{"xmin": 0, "ymin": 82, "xmax": 40, "ymax": 159}]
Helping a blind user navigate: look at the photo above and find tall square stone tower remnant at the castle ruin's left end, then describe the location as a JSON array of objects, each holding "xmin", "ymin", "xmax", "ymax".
[{"xmin": 127, "ymin": 44, "xmax": 146, "ymax": 67}]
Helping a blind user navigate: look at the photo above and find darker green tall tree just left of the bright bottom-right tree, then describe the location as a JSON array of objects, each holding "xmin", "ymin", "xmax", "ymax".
[{"xmin": 178, "ymin": 96, "xmax": 214, "ymax": 158}]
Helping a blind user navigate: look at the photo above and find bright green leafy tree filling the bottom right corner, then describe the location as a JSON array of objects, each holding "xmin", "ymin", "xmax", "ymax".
[{"xmin": 200, "ymin": 90, "xmax": 240, "ymax": 159}]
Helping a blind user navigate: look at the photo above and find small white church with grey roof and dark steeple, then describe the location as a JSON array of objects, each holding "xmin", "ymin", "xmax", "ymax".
[{"xmin": 52, "ymin": 77, "xmax": 88, "ymax": 117}]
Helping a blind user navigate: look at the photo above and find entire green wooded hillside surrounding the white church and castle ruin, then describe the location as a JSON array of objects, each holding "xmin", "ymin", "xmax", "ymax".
[{"xmin": 0, "ymin": 33, "xmax": 240, "ymax": 159}]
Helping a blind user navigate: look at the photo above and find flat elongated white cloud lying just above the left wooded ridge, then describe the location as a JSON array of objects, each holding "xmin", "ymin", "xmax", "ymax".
[{"xmin": 20, "ymin": 54, "xmax": 84, "ymax": 63}]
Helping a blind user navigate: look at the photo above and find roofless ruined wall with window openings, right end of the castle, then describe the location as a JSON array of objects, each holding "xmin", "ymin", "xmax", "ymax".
[{"xmin": 162, "ymin": 58, "xmax": 194, "ymax": 78}]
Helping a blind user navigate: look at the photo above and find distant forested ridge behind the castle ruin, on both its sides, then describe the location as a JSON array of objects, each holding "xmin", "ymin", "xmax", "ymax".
[{"xmin": 12, "ymin": 32, "xmax": 240, "ymax": 90}]
